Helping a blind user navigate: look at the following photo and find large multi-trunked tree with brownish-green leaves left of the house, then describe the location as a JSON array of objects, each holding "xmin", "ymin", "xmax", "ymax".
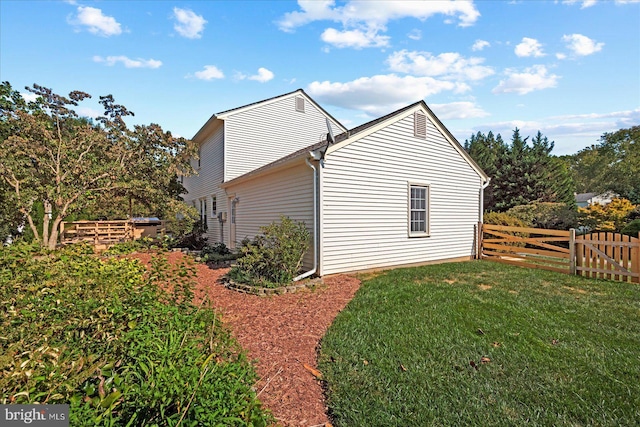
[{"xmin": 0, "ymin": 82, "xmax": 195, "ymax": 249}]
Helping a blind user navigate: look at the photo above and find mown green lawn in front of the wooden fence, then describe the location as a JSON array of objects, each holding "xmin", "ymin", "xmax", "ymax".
[{"xmin": 319, "ymin": 261, "xmax": 640, "ymax": 426}]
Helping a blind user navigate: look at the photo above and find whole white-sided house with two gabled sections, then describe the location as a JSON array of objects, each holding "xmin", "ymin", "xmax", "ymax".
[{"xmin": 184, "ymin": 90, "xmax": 489, "ymax": 276}]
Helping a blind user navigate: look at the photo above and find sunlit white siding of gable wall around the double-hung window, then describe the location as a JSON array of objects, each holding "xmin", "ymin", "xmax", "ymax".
[{"xmin": 321, "ymin": 113, "xmax": 481, "ymax": 275}]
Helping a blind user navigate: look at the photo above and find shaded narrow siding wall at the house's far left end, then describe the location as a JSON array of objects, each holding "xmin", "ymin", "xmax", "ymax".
[{"xmin": 183, "ymin": 125, "xmax": 226, "ymax": 243}]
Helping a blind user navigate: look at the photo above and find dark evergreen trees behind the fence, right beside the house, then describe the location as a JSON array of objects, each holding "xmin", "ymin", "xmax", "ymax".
[{"xmin": 465, "ymin": 128, "xmax": 574, "ymax": 212}]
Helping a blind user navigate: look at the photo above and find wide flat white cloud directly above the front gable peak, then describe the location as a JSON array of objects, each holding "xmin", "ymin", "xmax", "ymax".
[{"xmin": 307, "ymin": 74, "xmax": 470, "ymax": 117}]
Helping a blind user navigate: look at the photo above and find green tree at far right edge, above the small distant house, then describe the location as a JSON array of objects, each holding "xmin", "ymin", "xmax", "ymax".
[{"xmin": 566, "ymin": 126, "xmax": 640, "ymax": 204}]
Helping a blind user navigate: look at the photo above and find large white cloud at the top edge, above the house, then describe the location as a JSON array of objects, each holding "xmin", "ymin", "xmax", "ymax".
[{"xmin": 277, "ymin": 0, "xmax": 480, "ymax": 48}]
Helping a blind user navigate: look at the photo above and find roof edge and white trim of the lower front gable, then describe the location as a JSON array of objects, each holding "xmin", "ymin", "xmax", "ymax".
[{"xmin": 221, "ymin": 101, "xmax": 489, "ymax": 188}]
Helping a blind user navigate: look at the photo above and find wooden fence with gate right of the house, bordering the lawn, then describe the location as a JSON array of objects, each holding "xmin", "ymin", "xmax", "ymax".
[{"xmin": 478, "ymin": 224, "xmax": 640, "ymax": 283}]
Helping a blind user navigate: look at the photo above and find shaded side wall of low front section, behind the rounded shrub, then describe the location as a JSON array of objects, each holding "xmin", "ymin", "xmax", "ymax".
[{"xmin": 227, "ymin": 162, "xmax": 313, "ymax": 270}]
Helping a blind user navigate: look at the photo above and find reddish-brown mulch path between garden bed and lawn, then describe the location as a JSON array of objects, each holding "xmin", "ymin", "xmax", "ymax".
[{"xmin": 133, "ymin": 252, "xmax": 360, "ymax": 426}]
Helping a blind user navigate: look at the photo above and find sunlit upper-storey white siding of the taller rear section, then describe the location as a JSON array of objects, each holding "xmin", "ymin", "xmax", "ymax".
[{"xmin": 224, "ymin": 94, "xmax": 342, "ymax": 181}]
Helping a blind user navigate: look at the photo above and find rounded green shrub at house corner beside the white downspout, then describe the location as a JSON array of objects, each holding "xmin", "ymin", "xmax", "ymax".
[{"xmin": 229, "ymin": 216, "xmax": 310, "ymax": 287}]
